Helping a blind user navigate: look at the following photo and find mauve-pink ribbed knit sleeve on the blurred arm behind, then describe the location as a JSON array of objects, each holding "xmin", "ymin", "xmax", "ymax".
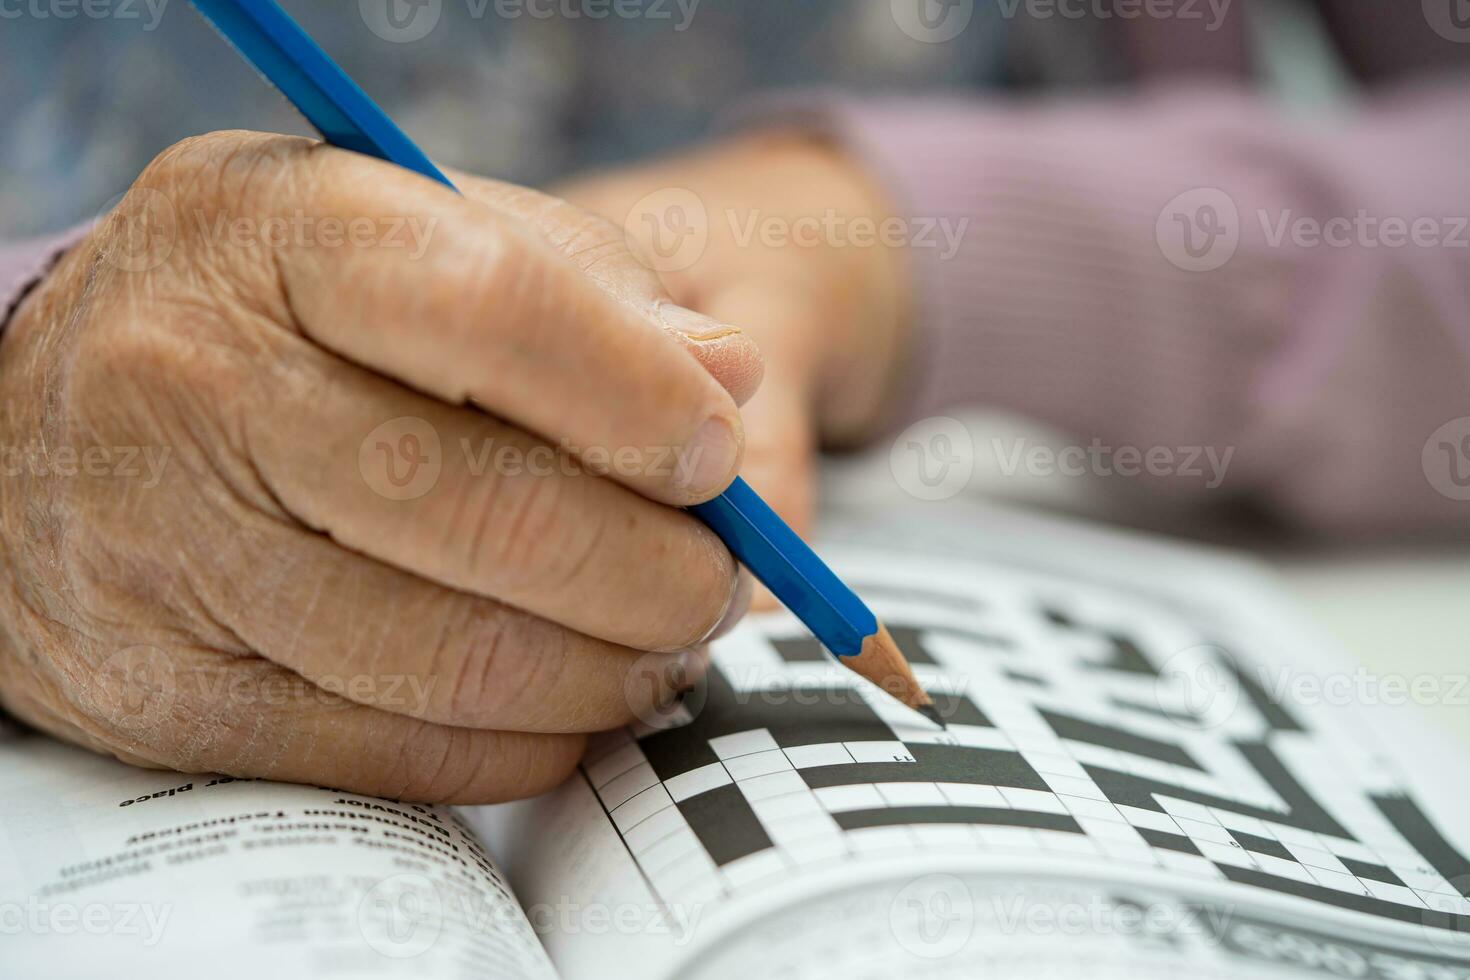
[{"xmin": 813, "ymin": 87, "xmax": 1470, "ymax": 533}]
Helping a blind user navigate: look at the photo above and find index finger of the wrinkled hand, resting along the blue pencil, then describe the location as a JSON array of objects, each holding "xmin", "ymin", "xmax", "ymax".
[{"xmin": 174, "ymin": 137, "xmax": 759, "ymax": 505}]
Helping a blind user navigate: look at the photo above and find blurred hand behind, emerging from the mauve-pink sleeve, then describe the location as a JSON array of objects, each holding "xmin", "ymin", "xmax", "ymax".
[{"xmin": 557, "ymin": 132, "xmax": 910, "ymax": 540}]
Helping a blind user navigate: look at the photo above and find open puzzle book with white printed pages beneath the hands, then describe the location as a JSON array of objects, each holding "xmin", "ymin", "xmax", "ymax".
[{"xmin": 0, "ymin": 508, "xmax": 1470, "ymax": 980}]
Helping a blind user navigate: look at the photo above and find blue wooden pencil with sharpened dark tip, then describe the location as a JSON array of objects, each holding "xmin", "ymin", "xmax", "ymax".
[{"xmin": 193, "ymin": 0, "xmax": 944, "ymax": 726}]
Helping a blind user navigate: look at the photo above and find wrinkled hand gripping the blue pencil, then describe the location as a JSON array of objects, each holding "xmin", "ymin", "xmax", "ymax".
[{"xmin": 0, "ymin": 134, "xmax": 761, "ymax": 802}]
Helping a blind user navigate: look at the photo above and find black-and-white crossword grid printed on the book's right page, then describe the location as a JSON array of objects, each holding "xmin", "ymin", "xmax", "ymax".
[{"xmin": 584, "ymin": 570, "xmax": 1470, "ymax": 930}]
